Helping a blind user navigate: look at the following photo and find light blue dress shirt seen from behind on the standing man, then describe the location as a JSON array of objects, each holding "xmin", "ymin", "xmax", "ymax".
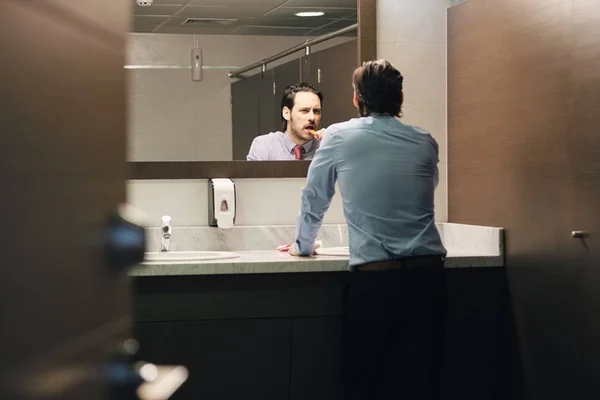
[{"xmin": 295, "ymin": 115, "xmax": 446, "ymax": 269}]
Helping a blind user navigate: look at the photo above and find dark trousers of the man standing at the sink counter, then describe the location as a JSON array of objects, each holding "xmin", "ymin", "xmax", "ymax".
[{"xmin": 342, "ymin": 257, "xmax": 446, "ymax": 400}]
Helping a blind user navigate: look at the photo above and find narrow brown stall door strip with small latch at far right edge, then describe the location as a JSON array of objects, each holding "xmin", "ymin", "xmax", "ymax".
[{"xmin": 564, "ymin": 0, "xmax": 600, "ymax": 386}]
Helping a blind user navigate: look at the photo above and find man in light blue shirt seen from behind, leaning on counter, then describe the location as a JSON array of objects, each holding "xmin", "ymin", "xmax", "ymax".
[{"xmin": 290, "ymin": 60, "xmax": 446, "ymax": 400}]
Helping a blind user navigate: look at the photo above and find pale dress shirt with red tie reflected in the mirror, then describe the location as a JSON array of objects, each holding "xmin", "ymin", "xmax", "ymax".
[{"xmin": 246, "ymin": 131, "xmax": 319, "ymax": 161}]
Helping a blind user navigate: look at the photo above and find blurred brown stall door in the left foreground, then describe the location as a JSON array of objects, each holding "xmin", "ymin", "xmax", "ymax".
[{"xmin": 0, "ymin": 0, "xmax": 131, "ymax": 400}]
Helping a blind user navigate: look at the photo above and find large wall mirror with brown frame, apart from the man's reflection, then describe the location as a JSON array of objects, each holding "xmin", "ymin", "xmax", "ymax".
[{"xmin": 125, "ymin": 0, "xmax": 376, "ymax": 179}]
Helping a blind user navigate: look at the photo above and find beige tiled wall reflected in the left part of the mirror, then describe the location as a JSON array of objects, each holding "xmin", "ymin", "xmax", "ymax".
[{"xmin": 127, "ymin": 33, "xmax": 352, "ymax": 161}]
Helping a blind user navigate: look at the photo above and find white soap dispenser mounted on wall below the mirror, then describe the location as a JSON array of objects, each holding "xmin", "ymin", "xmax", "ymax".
[{"xmin": 208, "ymin": 178, "xmax": 235, "ymax": 229}]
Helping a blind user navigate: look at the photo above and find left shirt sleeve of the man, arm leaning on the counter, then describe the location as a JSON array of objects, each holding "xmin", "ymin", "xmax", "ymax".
[{"xmin": 295, "ymin": 132, "xmax": 337, "ymax": 256}]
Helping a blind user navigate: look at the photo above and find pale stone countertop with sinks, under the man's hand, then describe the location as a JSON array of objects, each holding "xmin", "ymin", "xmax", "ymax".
[{"xmin": 129, "ymin": 250, "xmax": 504, "ymax": 276}]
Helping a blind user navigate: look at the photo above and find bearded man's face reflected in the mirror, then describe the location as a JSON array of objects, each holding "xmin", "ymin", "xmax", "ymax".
[{"xmin": 283, "ymin": 92, "xmax": 321, "ymax": 144}]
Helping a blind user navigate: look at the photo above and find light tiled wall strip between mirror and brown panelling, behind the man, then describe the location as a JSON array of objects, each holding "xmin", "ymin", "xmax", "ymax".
[{"xmin": 377, "ymin": 0, "xmax": 448, "ymax": 221}]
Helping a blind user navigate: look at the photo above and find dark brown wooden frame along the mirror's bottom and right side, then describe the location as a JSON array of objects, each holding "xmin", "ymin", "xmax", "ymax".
[{"xmin": 127, "ymin": 0, "xmax": 377, "ymax": 179}]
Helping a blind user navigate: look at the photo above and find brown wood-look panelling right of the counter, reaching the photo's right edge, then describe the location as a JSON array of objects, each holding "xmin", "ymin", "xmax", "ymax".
[{"xmin": 448, "ymin": 0, "xmax": 600, "ymax": 399}]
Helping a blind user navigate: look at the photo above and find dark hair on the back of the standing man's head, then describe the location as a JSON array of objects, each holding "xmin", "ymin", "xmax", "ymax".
[{"xmin": 352, "ymin": 60, "xmax": 404, "ymax": 117}]
